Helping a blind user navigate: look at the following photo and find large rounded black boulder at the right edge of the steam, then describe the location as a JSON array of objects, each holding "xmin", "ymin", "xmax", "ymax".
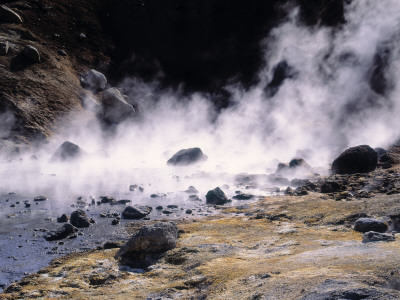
[{"xmin": 332, "ymin": 145, "xmax": 378, "ymax": 174}]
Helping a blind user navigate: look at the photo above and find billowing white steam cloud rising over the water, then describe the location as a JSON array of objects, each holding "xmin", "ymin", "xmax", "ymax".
[{"xmin": 2, "ymin": 0, "xmax": 400, "ymax": 201}]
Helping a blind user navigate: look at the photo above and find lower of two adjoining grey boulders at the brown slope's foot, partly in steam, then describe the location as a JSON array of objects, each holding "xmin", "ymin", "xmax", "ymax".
[{"xmin": 103, "ymin": 88, "xmax": 135, "ymax": 124}]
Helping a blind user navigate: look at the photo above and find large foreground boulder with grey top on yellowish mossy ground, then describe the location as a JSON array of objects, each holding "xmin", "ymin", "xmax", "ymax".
[{"xmin": 115, "ymin": 222, "xmax": 178, "ymax": 267}]
